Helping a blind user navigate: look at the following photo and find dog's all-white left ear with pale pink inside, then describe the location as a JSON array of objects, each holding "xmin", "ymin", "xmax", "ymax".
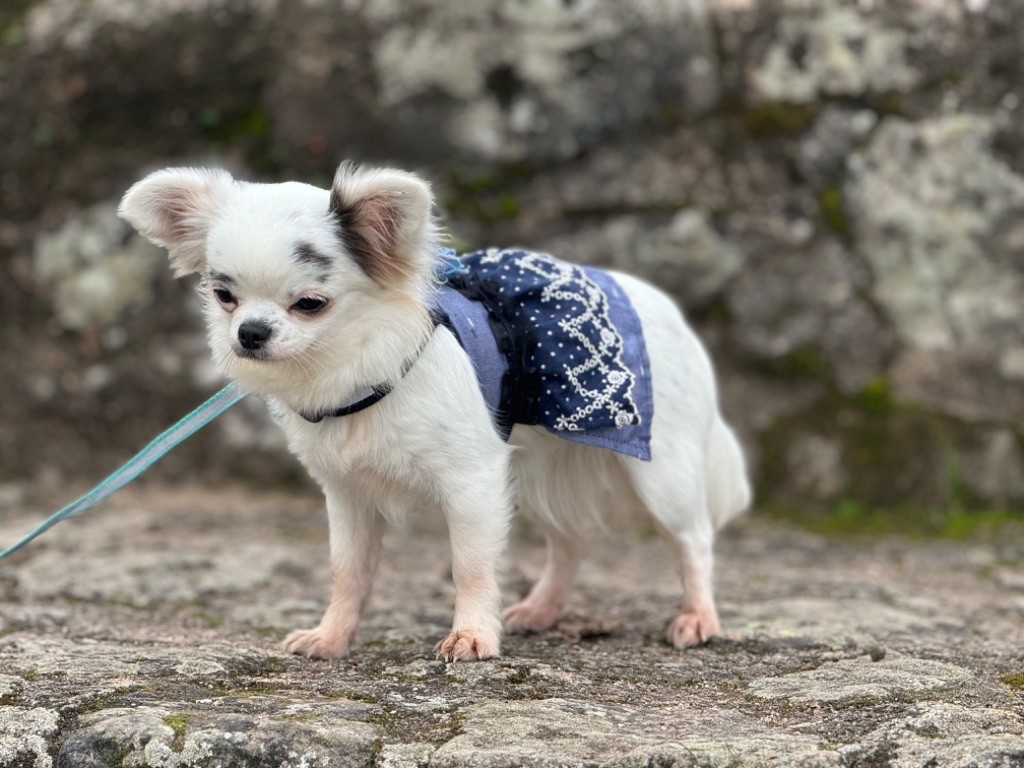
[{"xmin": 118, "ymin": 168, "xmax": 233, "ymax": 278}]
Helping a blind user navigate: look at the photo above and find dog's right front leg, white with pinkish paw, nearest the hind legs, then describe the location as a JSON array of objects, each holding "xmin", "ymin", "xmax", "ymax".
[{"xmin": 436, "ymin": 479, "xmax": 511, "ymax": 662}]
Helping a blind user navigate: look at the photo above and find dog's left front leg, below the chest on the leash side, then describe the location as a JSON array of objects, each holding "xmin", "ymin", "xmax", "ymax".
[{"xmin": 285, "ymin": 487, "xmax": 382, "ymax": 658}]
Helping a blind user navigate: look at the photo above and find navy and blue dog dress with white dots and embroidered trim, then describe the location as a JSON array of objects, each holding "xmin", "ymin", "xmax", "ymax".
[{"xmin": 436, "ymin": 249, "xmax": 653, "ymax": 460}]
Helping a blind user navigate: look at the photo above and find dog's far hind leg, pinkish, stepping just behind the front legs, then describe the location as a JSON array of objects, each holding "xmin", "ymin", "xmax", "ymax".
[{"xmin": 503, "ymin": 526, "xmax": 583, "ymax": 632}]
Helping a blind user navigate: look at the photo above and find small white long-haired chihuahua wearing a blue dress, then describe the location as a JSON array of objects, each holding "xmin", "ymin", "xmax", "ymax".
[{"xmin": 119, "ymin": 163, "xmax": 751, "ymax": 662}]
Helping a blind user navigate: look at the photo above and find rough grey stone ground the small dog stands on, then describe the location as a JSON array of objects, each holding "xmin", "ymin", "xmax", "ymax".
[{"xmin": 0, "ymin": 485, "xmax": 1024, "ymax": 768}]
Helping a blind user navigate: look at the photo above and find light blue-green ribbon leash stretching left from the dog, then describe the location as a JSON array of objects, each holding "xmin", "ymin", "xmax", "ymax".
[{"xmin": 0, "ymin": 384, "xmax": 246, "ymax": 558}]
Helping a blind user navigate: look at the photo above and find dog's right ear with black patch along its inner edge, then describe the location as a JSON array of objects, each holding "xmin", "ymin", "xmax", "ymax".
[{"xmin": 331, "ymin": 162, "xmax": 433, "ymax": 287}]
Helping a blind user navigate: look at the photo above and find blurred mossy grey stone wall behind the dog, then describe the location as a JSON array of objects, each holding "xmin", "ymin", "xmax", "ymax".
[{"xmin": 0, "ymin": 0, "xmax": 1024, "ymax": 520}]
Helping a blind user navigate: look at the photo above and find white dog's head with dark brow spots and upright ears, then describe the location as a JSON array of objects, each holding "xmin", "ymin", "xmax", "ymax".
[{"xmin": 119, "ymin": 163, "xmax": 436, "ymax": 391}]
